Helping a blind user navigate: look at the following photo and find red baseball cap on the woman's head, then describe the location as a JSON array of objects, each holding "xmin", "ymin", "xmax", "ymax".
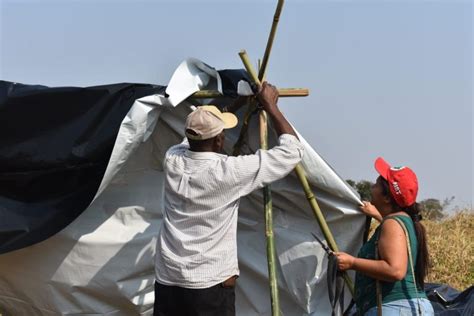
[{"xmin": 375, "ymin": 157, "xmax": 418, "ymax": 207}]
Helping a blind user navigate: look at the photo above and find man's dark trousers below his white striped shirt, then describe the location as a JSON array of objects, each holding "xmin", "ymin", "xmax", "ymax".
[{"xmin": 153, "ymin": 282, "xmax": 235, "ymax": 316}]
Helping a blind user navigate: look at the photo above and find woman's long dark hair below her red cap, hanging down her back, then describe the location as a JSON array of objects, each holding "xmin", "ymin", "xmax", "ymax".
[{"xmin": 379, "ymin": 177, "xmax": 430, "ymax": 289}]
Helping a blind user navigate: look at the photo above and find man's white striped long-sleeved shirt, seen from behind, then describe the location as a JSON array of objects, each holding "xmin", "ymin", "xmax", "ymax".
[{"xmin": 155, "ymin": 134, "xmax": 303, "ymax": 289}]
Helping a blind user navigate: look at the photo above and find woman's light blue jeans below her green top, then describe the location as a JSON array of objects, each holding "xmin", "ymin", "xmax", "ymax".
[{"xmin": 365, "ymin": 298, "xmax": 434, "ymax": 316}]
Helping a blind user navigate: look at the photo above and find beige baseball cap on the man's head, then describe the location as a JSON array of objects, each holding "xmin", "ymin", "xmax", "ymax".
[{"xmin": 185, "ymin": 105, "xmax": 238, "ymax": 140}]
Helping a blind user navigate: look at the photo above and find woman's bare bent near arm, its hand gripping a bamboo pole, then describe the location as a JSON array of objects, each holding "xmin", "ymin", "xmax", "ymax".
[{"xmin": 335, "ymin": 219, "xmax": 408, "ymax": 282}]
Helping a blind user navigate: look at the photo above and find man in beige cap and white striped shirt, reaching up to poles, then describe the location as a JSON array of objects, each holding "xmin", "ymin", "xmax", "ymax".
[{"xmin": 154, "ymin": 83, "xmax": 303, "ymax": 316}]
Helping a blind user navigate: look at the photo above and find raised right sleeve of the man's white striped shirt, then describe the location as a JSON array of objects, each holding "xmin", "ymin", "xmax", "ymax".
[{"xmin": 229, "ymin": 134, "xmax": 304, "ymax": 196}]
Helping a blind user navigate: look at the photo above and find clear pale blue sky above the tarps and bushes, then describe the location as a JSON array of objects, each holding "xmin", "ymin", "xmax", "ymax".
[{"xmin": 0, "ymin": 0, "xmax": 474, "ymax": 206}]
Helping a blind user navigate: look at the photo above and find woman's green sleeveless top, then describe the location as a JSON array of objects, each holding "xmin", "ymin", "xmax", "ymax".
[{"xmin": 354, "ymin": 215, "xmax": 426, "ymax": 315}]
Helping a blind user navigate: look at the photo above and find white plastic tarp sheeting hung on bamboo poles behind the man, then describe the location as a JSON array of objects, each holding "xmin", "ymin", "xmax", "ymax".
[{"xmin": 0, "ymin": 59, "xmax": 365, "ymax": 315}]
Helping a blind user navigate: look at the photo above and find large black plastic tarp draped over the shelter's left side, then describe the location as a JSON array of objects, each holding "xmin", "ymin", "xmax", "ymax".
[{"xmin": 0, "ymin": 81, "xmax": 165, "ymax": 253}]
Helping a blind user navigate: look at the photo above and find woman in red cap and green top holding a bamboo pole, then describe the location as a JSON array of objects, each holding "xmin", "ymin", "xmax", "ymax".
[{"xmin": 336, "ymin": 158, "xmax": 434, "ymax": 316}]
